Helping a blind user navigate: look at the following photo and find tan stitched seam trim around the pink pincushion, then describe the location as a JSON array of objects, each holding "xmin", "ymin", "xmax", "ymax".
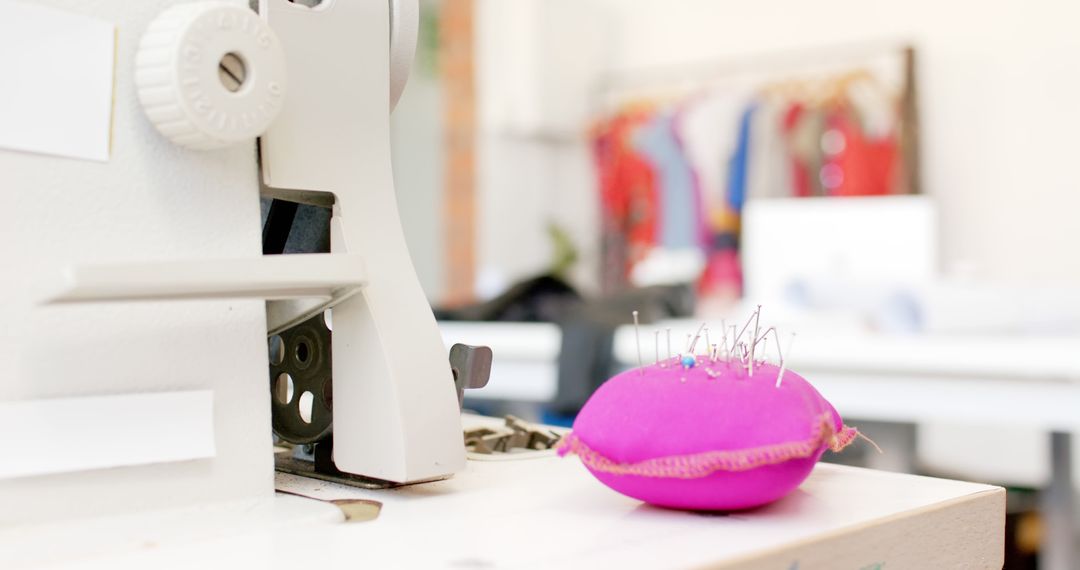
[{"xmin": 556, "ymin": 412, "xmax": 859, "ymax": 479}]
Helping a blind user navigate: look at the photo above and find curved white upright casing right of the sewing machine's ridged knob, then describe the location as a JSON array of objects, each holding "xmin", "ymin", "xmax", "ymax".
[{"xmin": 259, "ymin": 0, "xmax": 464, "ymax": 481}]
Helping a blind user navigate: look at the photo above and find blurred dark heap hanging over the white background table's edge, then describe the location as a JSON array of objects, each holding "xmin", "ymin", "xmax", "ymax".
[{"xmin": 435, "ymin": 274, "xmax": 694, "ymax": 415}]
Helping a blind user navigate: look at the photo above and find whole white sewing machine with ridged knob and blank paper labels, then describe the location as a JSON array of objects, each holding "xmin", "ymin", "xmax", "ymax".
[{"xmin": 0, "ymin": 0, "xmax": 490, "ymax": 523}]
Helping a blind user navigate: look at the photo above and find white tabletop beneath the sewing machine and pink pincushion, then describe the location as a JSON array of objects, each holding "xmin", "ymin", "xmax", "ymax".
[{"xmin": 0, "ymin": 433, "xmax": 1004, "ymax": 570}]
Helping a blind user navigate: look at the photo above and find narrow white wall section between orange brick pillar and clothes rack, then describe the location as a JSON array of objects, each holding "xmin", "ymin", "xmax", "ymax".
[{"xmin": 476, "ymin": 0, "xmax": 610, "ymax": 293}]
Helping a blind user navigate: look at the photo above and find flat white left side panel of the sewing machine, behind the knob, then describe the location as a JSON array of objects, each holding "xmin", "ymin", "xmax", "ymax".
[{"xmin": 0, "ymin": 0, "xmax": 273, "ymax": 525}]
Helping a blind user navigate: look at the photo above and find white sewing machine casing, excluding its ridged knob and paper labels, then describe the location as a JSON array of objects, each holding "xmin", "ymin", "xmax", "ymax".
[{"xmin": 0, "ymin": 0, "xmax": 464, "ymax": 523}]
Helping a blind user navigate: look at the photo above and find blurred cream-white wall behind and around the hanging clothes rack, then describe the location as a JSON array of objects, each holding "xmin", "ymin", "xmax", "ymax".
[{"xmin": 477, "ymin": 0, "xmax": 1080, "ymax": 291}]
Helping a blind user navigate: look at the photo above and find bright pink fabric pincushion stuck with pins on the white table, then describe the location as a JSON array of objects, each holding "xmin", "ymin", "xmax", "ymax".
[{"xmin": 559, "ymin": 356, "xmax": 856, "ymax": 511}]
